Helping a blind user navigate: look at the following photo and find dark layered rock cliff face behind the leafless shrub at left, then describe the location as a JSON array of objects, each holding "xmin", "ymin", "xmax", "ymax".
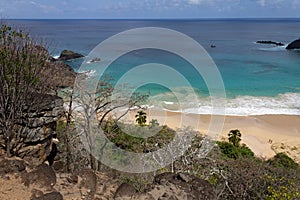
[{"xmin": 0, "ymin": 95, "xmax": 63, "ymax": 165}]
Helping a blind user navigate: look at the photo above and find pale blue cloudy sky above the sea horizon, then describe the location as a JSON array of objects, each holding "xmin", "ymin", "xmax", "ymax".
[{"xmin": 0, "ymin": 0, "xmax": 300, "ymax": 19}]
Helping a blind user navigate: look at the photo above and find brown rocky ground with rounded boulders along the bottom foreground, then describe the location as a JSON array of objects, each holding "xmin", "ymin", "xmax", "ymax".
[{"xmin": 0, "ymin": 157, "xmax": 216, "ymax": 200}]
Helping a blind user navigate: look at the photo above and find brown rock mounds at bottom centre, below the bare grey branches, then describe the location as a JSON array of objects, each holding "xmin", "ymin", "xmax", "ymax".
[{"xmin": 114, "ymin": 172, "xmax": 215, "ymax": 200}]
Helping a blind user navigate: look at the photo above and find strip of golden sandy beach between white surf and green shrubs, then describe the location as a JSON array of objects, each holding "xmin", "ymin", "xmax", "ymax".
[{"xmin": 122, "ymin": 109, "xmax": 300, "ymax": 163}]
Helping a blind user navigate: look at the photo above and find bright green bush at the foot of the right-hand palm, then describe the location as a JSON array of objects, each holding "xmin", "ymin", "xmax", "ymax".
[{"xmin": 217, "ymin": 142, "xmax": 254, "ymax": 159}]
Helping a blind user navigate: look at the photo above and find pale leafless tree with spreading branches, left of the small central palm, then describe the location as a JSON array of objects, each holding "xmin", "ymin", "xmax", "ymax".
[{"xmin": 69, "ymin": 74, "xmax": 148, "ymax": 170}]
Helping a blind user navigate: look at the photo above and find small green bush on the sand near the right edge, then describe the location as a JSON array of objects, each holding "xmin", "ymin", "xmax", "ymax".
[{"xmin": 268, "ymin": 153, "xmax": 299, "ymax": 169}]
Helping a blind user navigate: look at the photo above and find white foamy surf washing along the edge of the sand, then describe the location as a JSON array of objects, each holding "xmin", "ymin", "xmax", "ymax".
[{"xmin": 152, "ymin": 93, "xmax": 300, "ymax": 116}]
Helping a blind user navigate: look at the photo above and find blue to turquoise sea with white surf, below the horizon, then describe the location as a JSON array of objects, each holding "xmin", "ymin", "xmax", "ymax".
[{"xmin": 9, "ymin": 19, "xmax": 300, "ymax": 115}]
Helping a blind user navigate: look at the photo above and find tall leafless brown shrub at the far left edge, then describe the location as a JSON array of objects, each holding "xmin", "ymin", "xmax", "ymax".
[{"xmin": 0, "ymin": 23, "xmax": 49, "ymax": 157}]
